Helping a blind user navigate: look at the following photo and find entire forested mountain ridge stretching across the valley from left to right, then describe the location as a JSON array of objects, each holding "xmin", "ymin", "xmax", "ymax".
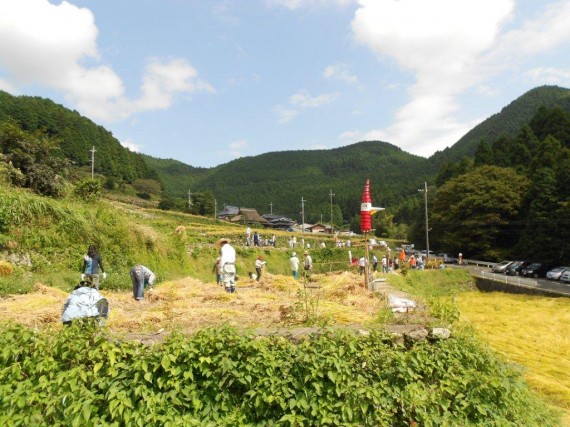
[{"xmin": 0, "ymin": 86, "xmax": 570, "ymax": 220}]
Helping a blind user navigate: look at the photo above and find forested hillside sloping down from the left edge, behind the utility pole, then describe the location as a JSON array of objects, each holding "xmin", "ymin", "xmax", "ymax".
[{"xmin": 0, "ymin": 91, "xmax": 158, "ymax": 182}]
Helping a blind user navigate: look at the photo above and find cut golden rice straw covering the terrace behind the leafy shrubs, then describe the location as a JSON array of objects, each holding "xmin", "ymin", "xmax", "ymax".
[{"xmin": 0, "ymin": 273, "xmax": 385, "ymax": 333}]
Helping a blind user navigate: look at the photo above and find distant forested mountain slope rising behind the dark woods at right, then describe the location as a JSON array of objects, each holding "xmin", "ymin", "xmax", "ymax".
[{"xmin": 430, "ymin": 86, "xmax": 570, "ymax": 167}]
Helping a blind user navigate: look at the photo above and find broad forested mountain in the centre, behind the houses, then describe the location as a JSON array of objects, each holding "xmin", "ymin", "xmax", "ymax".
[{"xmin": 189, "ymin": 141, "xmax": 428, "ymax": 223}]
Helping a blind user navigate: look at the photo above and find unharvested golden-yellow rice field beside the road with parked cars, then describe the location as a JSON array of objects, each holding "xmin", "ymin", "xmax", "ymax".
[{"xmin": 457, "ymin": 292, "xmax": 570, "ymax": 425}]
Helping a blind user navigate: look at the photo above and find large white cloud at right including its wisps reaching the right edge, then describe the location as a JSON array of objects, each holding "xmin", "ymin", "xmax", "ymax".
[{"xmin": 346, "ymin": 0, "xmax": 570, "ymax": 155}]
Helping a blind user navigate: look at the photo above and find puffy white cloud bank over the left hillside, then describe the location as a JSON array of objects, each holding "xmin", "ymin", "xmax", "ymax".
[{"xmin": 0, "ymin": 0, "xmax": 214, "ymax": 121}]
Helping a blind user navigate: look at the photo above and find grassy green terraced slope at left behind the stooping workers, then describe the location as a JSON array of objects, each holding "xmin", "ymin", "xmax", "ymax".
[{"xmin": 0, "ymin": 188, "xmax": 189, "ymax": 295}]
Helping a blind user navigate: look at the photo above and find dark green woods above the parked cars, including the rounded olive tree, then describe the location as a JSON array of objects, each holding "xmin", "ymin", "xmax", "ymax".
[{"xmin": 431, "ymin": 107, "xmax": 570, "ymax": 265}]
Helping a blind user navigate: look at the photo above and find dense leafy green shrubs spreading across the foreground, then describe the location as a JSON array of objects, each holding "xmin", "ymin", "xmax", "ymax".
[{"xmin": 0, "ymin": 324, "xmax": 557, "ymax": 426}]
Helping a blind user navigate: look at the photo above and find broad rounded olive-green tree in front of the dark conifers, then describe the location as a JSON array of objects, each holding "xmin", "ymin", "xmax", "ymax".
[{"xmin": 430, "ymin": 166, "xmax": 528, "ymax": 259}]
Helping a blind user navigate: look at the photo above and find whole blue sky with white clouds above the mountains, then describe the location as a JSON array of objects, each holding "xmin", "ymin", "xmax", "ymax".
[{"xmin": 0, "ymin": 0, "xmax": 570, "ymax": 167}]
